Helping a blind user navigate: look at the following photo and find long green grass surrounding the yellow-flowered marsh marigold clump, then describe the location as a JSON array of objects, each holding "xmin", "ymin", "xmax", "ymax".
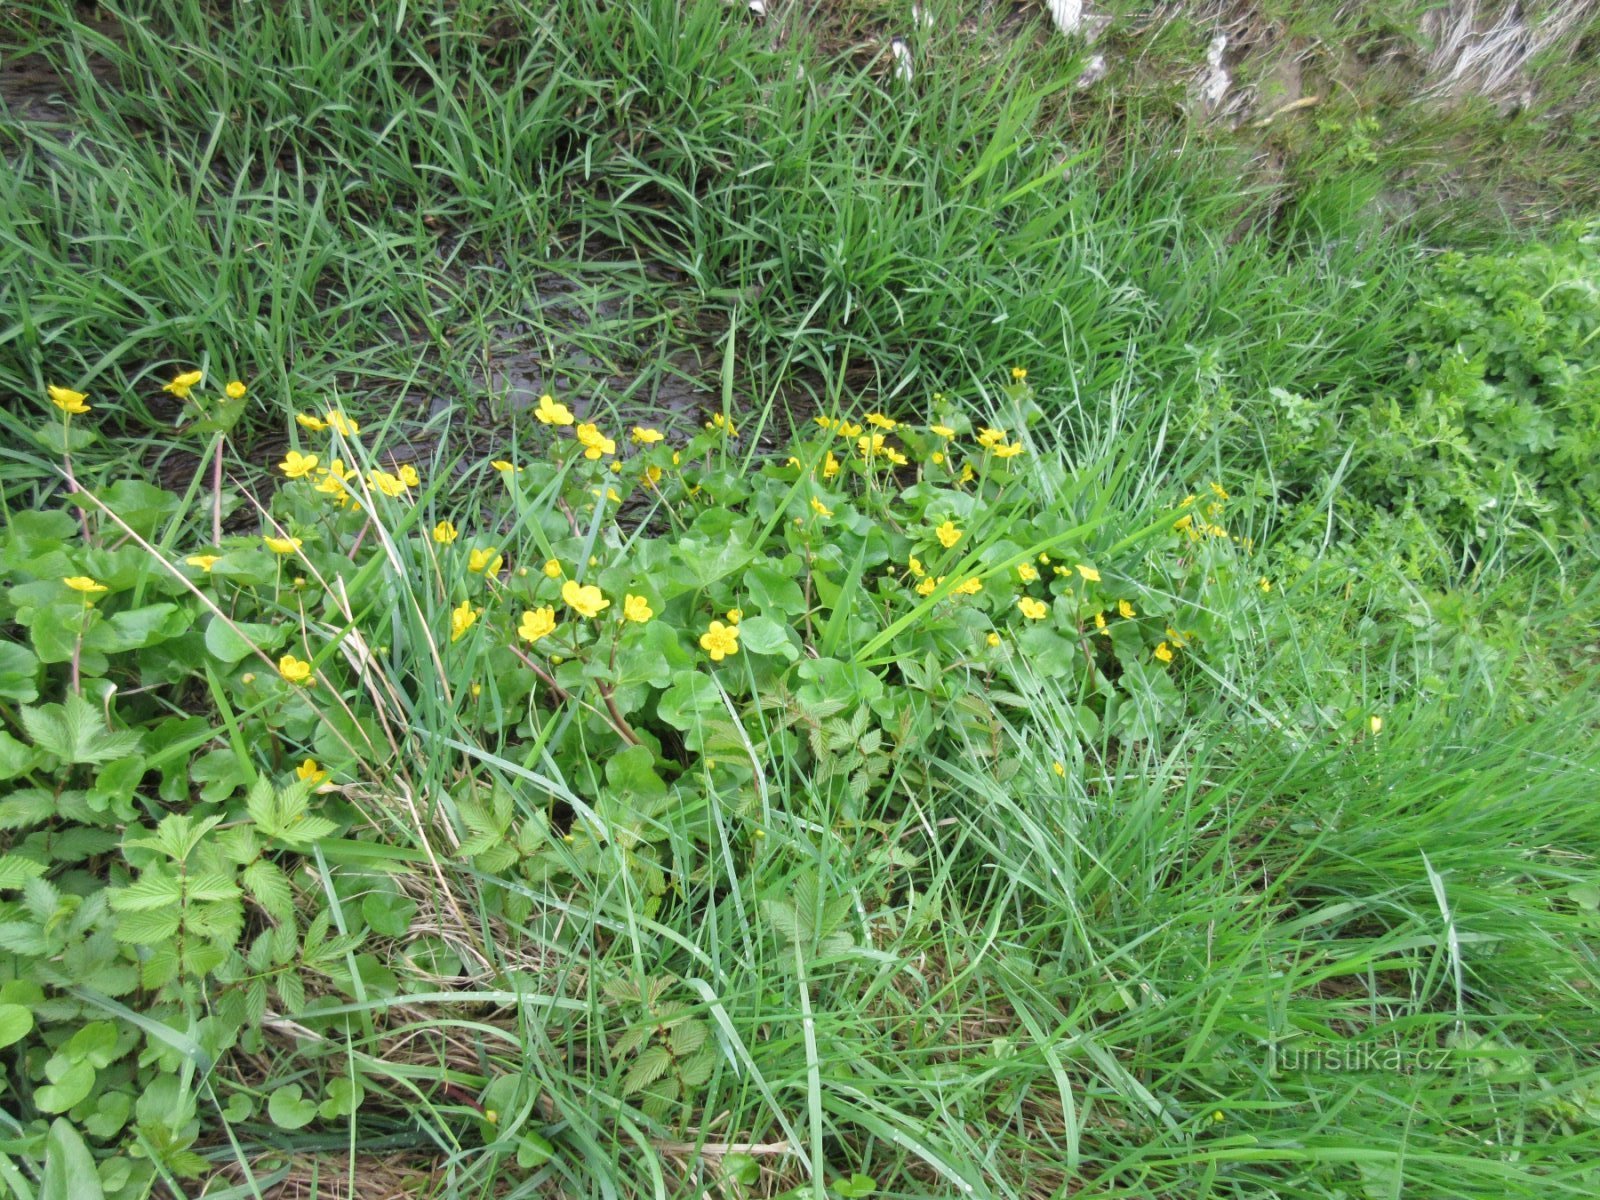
[{"xmin": 0, "ymin": 0, "xmax": 1600, "ymax": 1200}]
